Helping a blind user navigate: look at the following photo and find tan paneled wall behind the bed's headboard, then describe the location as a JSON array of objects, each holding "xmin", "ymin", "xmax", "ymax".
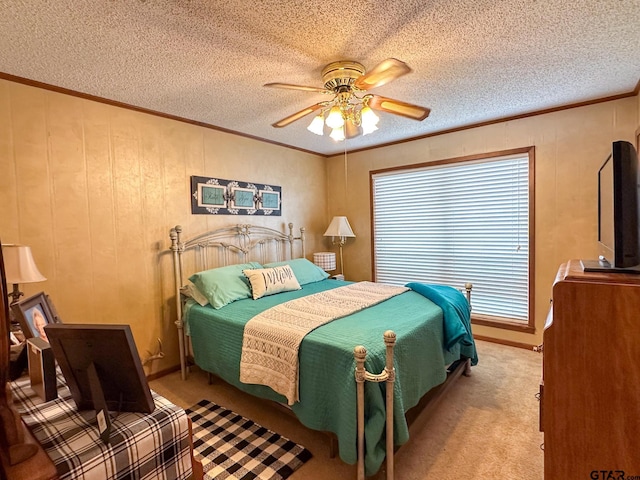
[{"xmin": 0, "ymin": 80, "xmax": 327, "ymax": 373}]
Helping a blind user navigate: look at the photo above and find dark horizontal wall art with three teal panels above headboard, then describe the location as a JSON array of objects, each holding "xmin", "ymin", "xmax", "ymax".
[{"xmin": 191, "ymin": 175, "xmax": 282, "ymax": 216}]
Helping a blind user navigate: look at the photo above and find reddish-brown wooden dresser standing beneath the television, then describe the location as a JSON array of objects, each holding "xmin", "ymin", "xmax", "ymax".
[{"xmin": 540, "ymin": 260, "xmax": 640, "ymax": 480}]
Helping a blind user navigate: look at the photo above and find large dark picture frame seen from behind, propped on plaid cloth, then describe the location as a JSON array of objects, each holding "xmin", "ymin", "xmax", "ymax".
[{"xmin": 44, "ymin": 323, "xmax": 155, "ymax": 443}]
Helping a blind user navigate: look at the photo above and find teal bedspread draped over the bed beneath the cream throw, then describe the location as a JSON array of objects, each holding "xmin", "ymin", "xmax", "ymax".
[{"xmin": 186, "ymin": 279, "xmax": 475, "ymax": 475}]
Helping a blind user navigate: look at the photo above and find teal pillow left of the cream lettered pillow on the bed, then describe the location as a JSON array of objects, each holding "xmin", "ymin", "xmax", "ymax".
[{"xmin": 189, "ymin": 262, "xmax": 262, "ymax": 309}]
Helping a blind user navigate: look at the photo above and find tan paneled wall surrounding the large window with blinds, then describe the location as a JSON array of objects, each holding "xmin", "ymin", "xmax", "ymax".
[{"xmin": 327, "ymin": 97, "xmax": 640, "ymax": 345}]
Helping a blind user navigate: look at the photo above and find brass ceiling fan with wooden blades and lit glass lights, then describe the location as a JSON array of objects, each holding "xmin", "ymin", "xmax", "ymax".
[{"xmin": 264, "ymin": 58, "xmax": 430, "ymax": 141}]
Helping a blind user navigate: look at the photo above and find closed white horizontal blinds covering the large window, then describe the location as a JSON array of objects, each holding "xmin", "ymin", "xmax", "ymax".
[{"xmin": 372, "ymin": 153, "xmax": 529, "ymax": 322}]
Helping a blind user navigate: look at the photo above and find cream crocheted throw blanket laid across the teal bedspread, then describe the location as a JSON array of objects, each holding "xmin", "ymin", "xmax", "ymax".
[{"xmin": 240, "ymin": 282, "xmax": 408, "ymax": 405}]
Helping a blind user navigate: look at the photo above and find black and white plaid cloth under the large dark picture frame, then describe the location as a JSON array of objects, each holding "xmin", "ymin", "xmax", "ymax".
[{"xmin": 12, "ymin": 372, "xmax": 192, "ymax": 480}]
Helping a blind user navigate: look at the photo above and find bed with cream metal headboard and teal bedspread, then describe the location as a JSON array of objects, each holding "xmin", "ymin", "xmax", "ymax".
[{"xmin": 170, "ymin": 224, "xmax": 477, "ymax": 475}]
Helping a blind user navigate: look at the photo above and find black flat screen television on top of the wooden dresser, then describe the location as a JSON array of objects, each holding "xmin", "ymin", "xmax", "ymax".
[{"xmin": 583, "ymin": 140, "xmax": 640, "ymax": 273}]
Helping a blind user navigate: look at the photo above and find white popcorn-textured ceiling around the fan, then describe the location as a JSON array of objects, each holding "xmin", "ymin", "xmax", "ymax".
[{"xmin": 0, "ymin": 0, "xmax": 640, "ymax": 155}]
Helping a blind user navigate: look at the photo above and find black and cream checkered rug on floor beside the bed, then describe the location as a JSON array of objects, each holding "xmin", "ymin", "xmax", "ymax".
[{"xmin": 186, "ymin": 400, "xmax": 311, "ymax": 480}]
